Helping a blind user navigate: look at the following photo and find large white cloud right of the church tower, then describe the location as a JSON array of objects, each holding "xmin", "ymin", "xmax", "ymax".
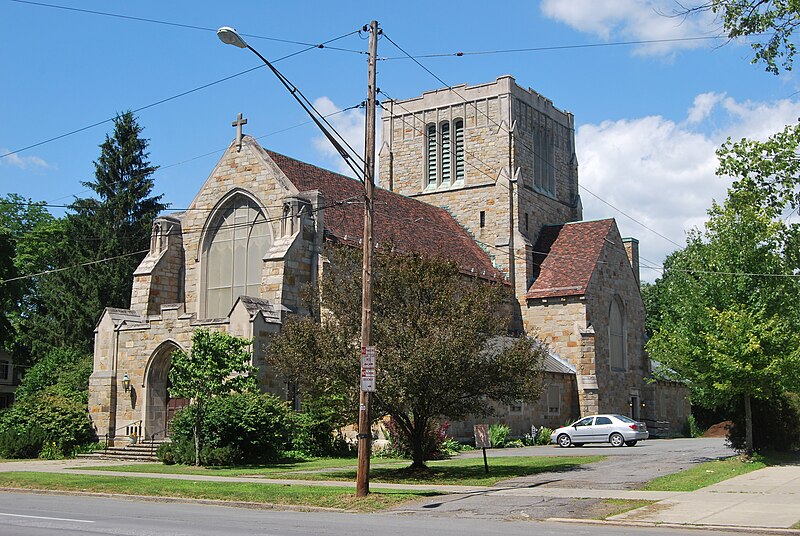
[{"xmin": 576, "ymin": 94, "xmax": 800, "ymax": 280}]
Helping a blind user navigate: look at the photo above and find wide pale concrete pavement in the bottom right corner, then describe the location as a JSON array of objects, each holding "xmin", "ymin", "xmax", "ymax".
[{"xmin": 610, "ymin": 465, "xmax": 800, "ymax": 534}]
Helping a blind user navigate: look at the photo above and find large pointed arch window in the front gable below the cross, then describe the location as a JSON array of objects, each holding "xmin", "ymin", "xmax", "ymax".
[{"xmin": 203, "ymin": 195, "xmax": 271, "ymax": 318}]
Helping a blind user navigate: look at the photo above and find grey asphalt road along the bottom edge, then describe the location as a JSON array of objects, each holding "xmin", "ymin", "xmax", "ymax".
[{"xmin": 0, "ymin": 493, "xmax": 748, "ymax": 536}]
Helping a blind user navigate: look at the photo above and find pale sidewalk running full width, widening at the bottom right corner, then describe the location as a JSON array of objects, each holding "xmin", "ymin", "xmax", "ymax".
[{"xmin": 0, "ymin": 460, "xmax": 800, "ymax": 535}]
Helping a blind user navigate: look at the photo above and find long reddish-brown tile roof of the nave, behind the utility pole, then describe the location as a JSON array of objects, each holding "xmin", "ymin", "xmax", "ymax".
[{"xmin": 266, "ymin": 150, "xmax": 503, "ymax": 279}]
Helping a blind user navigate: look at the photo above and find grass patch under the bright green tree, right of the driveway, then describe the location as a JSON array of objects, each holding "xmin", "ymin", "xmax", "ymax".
[{"xmin": 641, "ymin": 453, "xmax": 800, "ymax": 491}]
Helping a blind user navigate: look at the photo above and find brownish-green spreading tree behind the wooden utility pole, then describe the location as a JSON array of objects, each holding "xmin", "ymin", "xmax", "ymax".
[{"xmin": 268, "ymin": 248, "xmax": 547, "ymax": 467}]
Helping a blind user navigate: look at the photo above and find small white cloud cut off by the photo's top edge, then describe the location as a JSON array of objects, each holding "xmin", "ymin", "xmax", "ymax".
[{"xmin": 541, "ymin": 0, "xmax": 719, "ymax": 55}]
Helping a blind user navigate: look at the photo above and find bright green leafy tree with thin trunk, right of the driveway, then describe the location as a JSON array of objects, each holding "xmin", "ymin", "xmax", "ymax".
[{"xmin": 647, "ymin": 183, "xmax": 800, "ymax": 450}]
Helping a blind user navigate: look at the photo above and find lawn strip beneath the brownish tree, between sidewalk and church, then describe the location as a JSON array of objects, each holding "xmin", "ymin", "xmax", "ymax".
[{"xmin": 83, "ymin": 456, "xmax": 605, "ymax": 486}]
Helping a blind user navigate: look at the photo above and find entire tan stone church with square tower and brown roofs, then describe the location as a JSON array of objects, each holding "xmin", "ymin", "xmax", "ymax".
[{"xmin": 89, "ymin": 76, "xmax": 689, "ymax": 444}]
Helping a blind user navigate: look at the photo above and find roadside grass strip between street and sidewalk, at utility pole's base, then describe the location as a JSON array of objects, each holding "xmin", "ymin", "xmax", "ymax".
[{"xmin": 0, "ymin": 472, "xmax": 438, "ymax": 512}]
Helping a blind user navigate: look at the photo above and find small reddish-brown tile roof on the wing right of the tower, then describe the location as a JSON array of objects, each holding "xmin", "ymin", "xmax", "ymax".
[{"xmin": 526, "ymin": 219, "xmax": 614, "ymax": 299}]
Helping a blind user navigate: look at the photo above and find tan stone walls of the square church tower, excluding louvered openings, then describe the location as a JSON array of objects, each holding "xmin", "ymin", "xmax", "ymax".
[{"xmin": 380, "ymin": 76, "xmax": 581, "ymax": 288}]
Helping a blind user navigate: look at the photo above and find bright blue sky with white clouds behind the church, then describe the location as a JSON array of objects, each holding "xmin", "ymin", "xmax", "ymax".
[{"xmin": 0, "ymin": 0, "xmax": 800, "ymax": 280}]
